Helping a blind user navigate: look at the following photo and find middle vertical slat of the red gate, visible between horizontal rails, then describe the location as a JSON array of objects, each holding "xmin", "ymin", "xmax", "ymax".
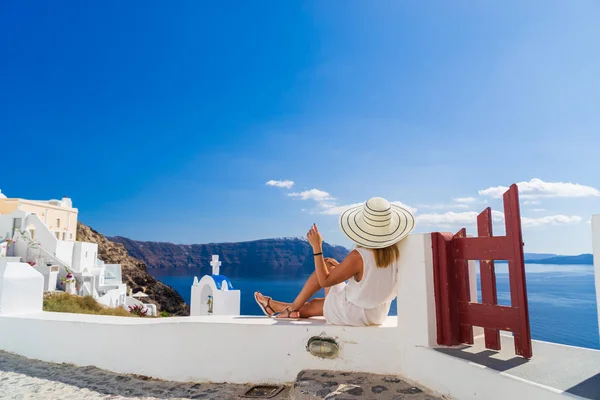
[{"xmin": 477, "ymin": 207, "xmax": 500, "ymax": 350}]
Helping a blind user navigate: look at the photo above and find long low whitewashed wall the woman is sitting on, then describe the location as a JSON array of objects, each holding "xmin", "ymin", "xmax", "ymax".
[{"xmin": 0, "ymin": 313, "xmax": 584, "ymax": 400}]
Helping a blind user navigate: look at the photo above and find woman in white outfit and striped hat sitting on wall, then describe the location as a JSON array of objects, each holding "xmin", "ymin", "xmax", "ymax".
[{"xmin": 254, "ymin": 197, "xmax": 415, "ymax": 326}]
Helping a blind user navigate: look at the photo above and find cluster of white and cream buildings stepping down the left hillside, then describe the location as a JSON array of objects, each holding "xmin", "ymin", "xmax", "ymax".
[{"xmin": 0, "ymin": 193, "xmax": 155, "ymax": 313}]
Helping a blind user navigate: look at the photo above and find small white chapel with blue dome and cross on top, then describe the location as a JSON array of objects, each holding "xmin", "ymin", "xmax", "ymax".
[{"xmin": 190, "ymin": 255, "xmax": 241, "ymax": 316}]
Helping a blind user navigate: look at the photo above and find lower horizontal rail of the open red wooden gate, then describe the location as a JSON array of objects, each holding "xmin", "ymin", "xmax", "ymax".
[{"xmin": 459, "ymin": 303, "xmax": 519, "ymax": 332}]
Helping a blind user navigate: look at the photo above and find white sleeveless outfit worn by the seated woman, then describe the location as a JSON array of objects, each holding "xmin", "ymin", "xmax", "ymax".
[{"xmin": 323, "ymin": 248, "xmax": 398, "ymax": 326}]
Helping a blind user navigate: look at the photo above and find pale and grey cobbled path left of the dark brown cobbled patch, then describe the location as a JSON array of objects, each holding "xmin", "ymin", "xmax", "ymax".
[{"xmin": 0, "ymin": 351, "xmax": 289, "ymax": 400}]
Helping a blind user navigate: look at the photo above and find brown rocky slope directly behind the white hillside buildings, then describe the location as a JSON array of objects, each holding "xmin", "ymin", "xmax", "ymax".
[{"xmin": 77, "ymin": 222, "xmax": 189, "ymax": 315}]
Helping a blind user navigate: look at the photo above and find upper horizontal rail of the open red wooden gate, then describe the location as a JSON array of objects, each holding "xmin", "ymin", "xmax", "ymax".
[{"xmin": 454, "ymin": 236, "xmax": 513, "ymax": 260}]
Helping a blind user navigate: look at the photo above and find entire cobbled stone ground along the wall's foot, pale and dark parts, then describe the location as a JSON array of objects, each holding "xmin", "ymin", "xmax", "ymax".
[{"xmin": 0, "ymin": 351, "xmax": 443, "ymax": 400}]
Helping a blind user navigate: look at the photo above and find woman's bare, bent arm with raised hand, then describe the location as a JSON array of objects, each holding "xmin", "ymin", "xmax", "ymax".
[{"xmin": 306, "ymin": 225, "xmax": 362, "ymax": 287}]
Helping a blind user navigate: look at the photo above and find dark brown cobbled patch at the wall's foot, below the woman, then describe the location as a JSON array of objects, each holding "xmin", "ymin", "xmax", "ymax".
[{"xmin": 290, "ymin": 370, "xmax": 444, "ymax": 400}]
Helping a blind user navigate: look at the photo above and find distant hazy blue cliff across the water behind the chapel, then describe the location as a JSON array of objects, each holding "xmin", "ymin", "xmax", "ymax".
[{"xmin": 110, "ymin": 237, "xmax": 348, "ymax": 279}]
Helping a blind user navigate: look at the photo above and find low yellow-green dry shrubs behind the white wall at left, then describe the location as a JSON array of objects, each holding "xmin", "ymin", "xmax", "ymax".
[{"xmin": 43, "ymin": 292, "xmax": 135, "ymax": 317}]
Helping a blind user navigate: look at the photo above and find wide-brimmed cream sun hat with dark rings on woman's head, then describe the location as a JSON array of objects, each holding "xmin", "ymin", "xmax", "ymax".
[{"xmin": 340, "ymin": 197, "xmax": 415, "ymax": 249}]
